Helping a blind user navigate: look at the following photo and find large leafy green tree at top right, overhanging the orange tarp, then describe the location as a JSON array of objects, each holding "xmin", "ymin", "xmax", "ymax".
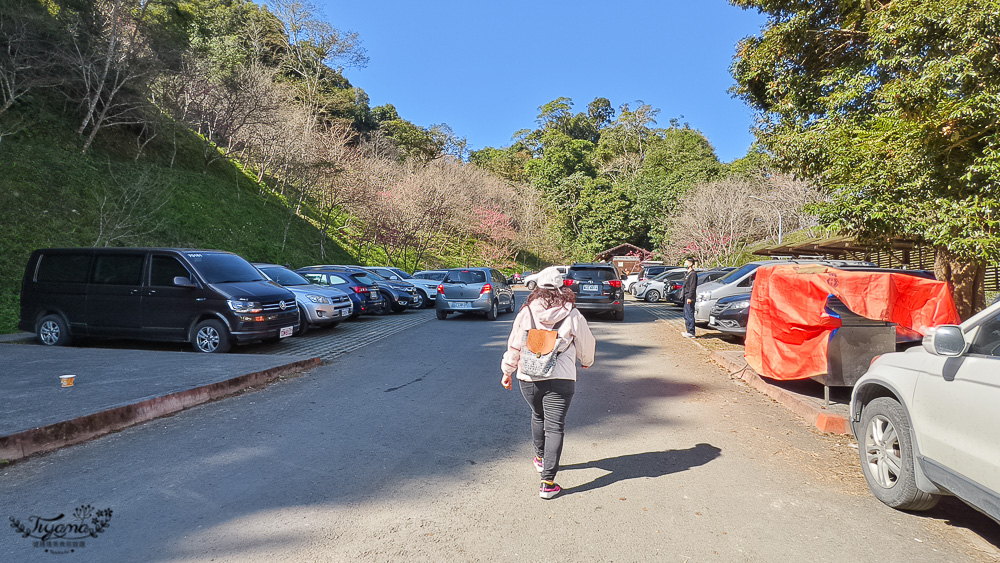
[{"xmin": 731, "ymin": 0, "xmax": 1000, "ymax": 318}]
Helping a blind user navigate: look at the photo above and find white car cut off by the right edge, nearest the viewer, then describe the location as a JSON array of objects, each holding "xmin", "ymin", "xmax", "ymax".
[{"xmin": 850, "ymin": 304, "xmax": 1000, "ymax": 522}]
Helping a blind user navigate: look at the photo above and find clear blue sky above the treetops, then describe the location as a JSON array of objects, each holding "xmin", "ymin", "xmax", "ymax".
[{"xmin": 317, "ymin": 0, "xmax": 764, "ymax": 162}]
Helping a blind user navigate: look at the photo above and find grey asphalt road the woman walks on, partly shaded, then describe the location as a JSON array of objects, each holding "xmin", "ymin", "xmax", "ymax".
[{"xmin": 0, "ymin": 300, "xmax": 1000, "ymax": 562}]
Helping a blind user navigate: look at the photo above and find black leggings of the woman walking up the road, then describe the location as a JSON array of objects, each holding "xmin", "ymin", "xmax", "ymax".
[{"xmin": 518, "ymin": 379, "xmax": 576, "ymax": 481}]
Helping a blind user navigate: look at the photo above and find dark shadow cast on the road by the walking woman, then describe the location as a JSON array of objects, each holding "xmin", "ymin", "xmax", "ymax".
[{"xmin": 559, "ymin": 443, "xmax": 722, "ymax": 494}]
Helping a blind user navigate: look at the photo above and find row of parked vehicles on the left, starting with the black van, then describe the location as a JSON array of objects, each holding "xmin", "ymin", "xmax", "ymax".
[{"xmin": 18, "ymin": 248, "xmax": 514, "ymax": 353}]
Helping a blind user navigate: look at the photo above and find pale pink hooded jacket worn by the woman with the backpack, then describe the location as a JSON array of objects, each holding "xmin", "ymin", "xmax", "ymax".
[{"xmin": 500, "ymin": 301, "xmax": 596, "ymax": 381}]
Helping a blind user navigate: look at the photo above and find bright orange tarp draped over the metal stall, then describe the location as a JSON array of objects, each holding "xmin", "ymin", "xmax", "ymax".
[{"xmin": 745, "ymin": 264, "xmax": 959, "ymax": 379}]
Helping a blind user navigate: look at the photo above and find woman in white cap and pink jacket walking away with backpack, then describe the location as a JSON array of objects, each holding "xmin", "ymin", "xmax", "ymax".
[{"xmin": 500, "ymin": 267, "xmax": 595, "ymax": 499}]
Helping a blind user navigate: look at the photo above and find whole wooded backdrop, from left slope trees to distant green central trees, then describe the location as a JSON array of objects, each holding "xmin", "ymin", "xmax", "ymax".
[{"xmin": 0, "ymin": 0, "xmax": 799, "ymax": 269}]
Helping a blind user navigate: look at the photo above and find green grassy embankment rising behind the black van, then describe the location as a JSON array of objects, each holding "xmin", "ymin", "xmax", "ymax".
[{"xmin": 0, "ymin": 99, "xmax": 516, "ymax": 333}]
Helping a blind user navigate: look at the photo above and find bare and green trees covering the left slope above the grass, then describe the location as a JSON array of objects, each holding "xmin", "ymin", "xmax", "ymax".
[{"xmin": 0, "ymin": 0, "xmax": 558, "ymax": 269}]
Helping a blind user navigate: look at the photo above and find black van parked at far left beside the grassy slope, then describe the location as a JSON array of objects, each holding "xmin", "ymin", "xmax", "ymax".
[{"xmin": 17, "ymin": 248, "xmax": 299, "ymax": 352}]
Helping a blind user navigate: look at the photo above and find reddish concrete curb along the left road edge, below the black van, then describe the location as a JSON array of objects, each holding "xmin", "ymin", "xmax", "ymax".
[{"xmin": 0, "ymin": 358, "xmax": 323, "ymax": 461}]
